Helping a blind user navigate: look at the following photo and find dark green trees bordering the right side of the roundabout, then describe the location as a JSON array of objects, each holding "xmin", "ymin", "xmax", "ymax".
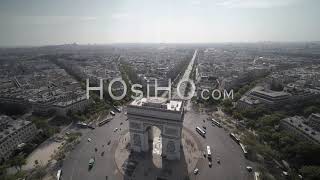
[{"xmin": 231, "ymin": 102, "xmax": 320, "ymax": 179}]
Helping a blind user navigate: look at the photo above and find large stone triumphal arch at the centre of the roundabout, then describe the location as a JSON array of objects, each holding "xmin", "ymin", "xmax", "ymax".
[{"xmin": 127, "ymin": 97, "xmax": 184, "ymax": 160}]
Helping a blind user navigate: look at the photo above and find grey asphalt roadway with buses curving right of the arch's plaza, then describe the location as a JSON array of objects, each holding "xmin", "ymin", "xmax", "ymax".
[{"xmin": 184, "ymin": 110, "xmax": 253, "ymax": 180}]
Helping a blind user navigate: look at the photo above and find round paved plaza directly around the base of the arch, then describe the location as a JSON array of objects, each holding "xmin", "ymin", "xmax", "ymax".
[{"xmin": 115, "ymin": 129, "xmax": 202, "ymax": 179}]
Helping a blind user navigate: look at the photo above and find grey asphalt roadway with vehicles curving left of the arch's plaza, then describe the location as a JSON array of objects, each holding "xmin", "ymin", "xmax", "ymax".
[{"xmin": 62, "ymin": 113, "xmax": 128, "ymax": 180}]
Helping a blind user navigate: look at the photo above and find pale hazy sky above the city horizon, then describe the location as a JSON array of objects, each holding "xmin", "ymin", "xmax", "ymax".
[{"xmin": 0, "ymin": 0, "xmax": 320, "ymax": 46}]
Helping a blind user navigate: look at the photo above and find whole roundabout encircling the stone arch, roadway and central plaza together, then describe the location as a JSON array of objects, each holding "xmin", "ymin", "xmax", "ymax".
[{"xmin": 61, "ymin": 104, "xmax": 253, "ymax": 180}]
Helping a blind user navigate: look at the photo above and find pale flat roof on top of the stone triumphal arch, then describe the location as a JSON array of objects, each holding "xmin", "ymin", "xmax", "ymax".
[{"xmin": 130, "ymin": 97, "xmax": 182, "ymax": 111}]
